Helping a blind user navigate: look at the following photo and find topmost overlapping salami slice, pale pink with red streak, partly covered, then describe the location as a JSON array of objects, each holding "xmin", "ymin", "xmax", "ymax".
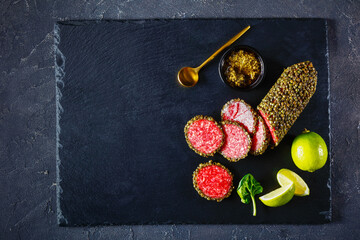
[{"xmin": 221, "ymin": 98, "xmax": 257, "ymax": 134}]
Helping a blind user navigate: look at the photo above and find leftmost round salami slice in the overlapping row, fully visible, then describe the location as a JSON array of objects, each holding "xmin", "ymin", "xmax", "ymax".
[{"xmin": 184, "ymin": 115, "xmax": 224, "ymax": 157}]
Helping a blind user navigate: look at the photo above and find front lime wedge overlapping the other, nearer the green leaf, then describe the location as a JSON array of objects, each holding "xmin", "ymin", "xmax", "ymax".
[{"xmin": 259, "ymin": 183, "xmax": 295, "ymax": 207}]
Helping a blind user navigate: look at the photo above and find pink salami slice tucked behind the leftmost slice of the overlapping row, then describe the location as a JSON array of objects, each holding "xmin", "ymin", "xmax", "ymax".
[{"xmin": 220, "ymin": 121, "xmax": 251, "ymax": 162}]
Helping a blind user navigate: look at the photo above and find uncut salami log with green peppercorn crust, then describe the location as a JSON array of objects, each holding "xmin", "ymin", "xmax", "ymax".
[{"xmin": 257, "ymin": 61, "xmax": 317, "ymax": 146}]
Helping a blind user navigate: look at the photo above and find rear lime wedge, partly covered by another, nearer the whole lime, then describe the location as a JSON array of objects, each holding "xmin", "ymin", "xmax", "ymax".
[{"xmin": 276, "ymin": 168, "xmax": 310, "ymax": 197}]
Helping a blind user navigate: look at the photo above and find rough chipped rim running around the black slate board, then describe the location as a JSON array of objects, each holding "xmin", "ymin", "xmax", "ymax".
[{"xmin": 54, "ymin": 18, "xmax": 332, "ymax": 226}]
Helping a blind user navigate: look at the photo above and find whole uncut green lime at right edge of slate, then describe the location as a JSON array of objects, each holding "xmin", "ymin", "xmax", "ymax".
[{"xmin": 291, "ymin": 129, "xmax": 328, "ymax": 172}]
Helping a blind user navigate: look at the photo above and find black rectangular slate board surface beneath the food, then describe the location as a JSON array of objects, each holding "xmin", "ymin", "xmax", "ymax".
[{"xmin": 55, "ymin": 19, "xmax": 331, "ymax": 226}]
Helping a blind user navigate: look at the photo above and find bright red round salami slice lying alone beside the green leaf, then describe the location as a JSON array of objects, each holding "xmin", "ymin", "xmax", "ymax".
[{"xmin": 193, "ymin": 161, "xmax": 234, "ymax": 202}]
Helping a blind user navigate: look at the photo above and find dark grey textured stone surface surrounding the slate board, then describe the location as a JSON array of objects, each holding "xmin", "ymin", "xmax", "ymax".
[{"xmin": 0, "ymin": 0, "xmax": 360, "ymax": 239}]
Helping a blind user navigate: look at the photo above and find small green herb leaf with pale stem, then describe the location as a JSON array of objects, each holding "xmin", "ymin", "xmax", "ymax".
[{"xmin": 237, "ymin": 173, "xmax": 263, "ymax": 216}]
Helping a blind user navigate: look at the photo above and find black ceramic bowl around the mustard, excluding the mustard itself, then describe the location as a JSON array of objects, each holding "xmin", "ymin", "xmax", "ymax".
[{"xmin": 219, "ymin": 45, "xmax": 265, "ymax": 90}]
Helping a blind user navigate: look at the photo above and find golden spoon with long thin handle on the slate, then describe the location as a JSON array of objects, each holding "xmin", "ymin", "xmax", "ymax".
[{"xmin": 177, "ymin": 26, "xmax": 250, "ymax": 87}]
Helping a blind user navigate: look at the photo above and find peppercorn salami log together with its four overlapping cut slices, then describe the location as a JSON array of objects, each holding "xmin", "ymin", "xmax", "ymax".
[{"xmin": 185, "ymin": 61, "xmax": 317, "ymax": 161}]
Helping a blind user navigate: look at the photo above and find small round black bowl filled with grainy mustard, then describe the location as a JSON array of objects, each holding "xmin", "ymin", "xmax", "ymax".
[{"xmin": 219, "ymin": 45, "xmax": 265, "ymax": 90}]
